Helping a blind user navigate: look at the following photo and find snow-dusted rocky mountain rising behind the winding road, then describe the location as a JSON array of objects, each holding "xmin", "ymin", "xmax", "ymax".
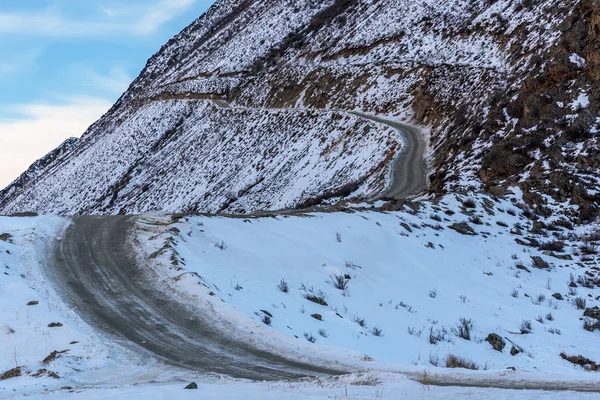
[{"xmin": 0, "ymin": 0, "xmax": 600, "ymax": 216}]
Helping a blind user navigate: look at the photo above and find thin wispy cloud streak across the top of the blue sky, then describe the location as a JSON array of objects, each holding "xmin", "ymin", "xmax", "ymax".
[{"xmin": 0, "ymin": 0, "xmax": 199, "ymax": 37}]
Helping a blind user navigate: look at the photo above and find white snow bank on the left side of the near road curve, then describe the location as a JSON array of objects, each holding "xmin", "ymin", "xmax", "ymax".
[{"xmin": 0, "ymin": 217, "xmax": 147, "ymax": 398}]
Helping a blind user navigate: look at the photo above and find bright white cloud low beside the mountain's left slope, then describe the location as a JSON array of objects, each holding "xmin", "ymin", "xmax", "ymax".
[{"xmin": 0, "ymin": 97, "xmax": 112, "ymax": 188}]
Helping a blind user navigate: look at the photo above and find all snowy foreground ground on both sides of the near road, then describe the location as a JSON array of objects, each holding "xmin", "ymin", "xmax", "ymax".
[{"xmin": 0, "ymin": 191, "xmax": 600, "ymax": 399}]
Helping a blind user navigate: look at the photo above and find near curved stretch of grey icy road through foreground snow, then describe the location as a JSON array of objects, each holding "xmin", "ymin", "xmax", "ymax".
[{"xmin": 48, "ymin": 216, "xmax": 342, "ymax": 380}]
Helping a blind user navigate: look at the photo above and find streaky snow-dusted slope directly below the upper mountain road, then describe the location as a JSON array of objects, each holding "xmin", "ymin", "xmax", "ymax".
[{"xmin": 3, "ymin": 100, "xmax": 401, "ymax": 215}]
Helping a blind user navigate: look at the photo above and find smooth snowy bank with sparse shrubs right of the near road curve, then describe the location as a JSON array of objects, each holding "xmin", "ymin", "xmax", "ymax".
[{"xmin": 138, "ymin": 195, "xmax": 600, "ymax": 380}]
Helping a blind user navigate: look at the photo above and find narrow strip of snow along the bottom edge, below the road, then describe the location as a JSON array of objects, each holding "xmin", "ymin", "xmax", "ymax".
[{"xmin": 14, "ymin": 374, "xmax": 598, "ymax": 400}]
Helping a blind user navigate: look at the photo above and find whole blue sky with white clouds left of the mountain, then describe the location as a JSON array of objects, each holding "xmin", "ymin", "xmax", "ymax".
[{"xmin": 0, "ymin": 0, "xmax": 215, "ymax": 189}]
